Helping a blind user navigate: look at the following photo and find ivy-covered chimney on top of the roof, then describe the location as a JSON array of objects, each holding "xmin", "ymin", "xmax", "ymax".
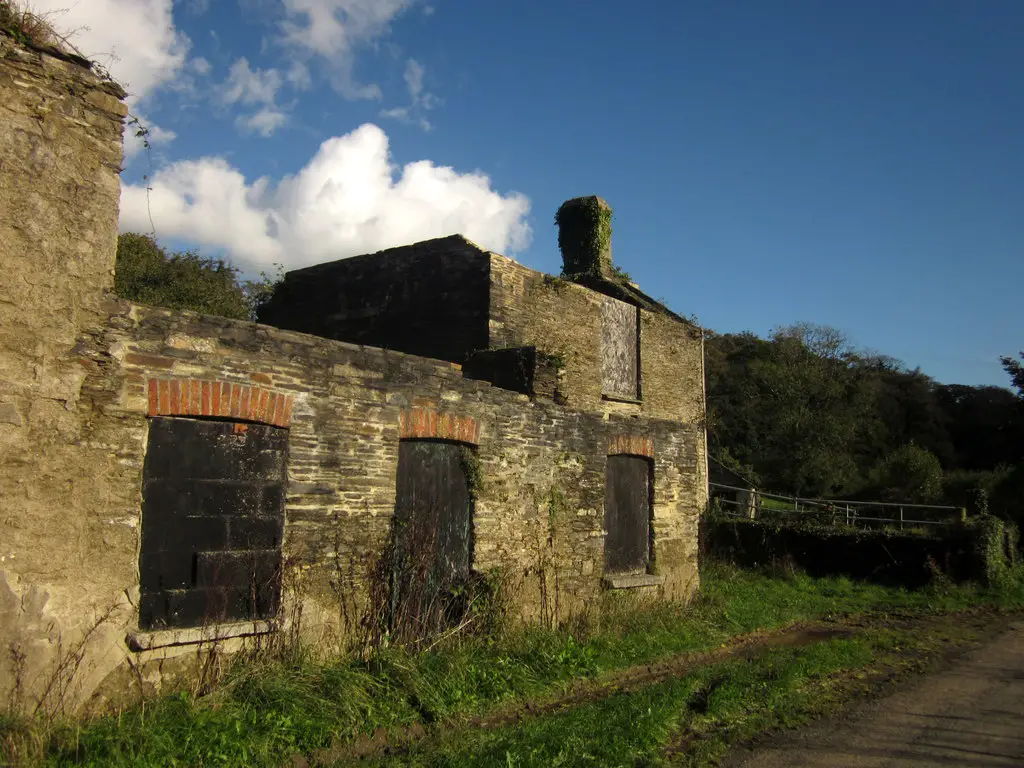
[{"xmin": 555, "ymin": 195, "xmax": 614, "ymax": 280}]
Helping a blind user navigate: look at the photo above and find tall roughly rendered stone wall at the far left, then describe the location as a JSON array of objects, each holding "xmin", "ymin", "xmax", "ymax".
[{"xmin": 0, "ymin": 34, "xmax": 137, "ymax": 716}]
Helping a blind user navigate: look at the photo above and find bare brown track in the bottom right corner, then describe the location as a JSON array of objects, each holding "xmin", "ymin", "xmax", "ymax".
[{"xmin": 726, "ymin": 621, "xmax": 1024, "ymax": 768}]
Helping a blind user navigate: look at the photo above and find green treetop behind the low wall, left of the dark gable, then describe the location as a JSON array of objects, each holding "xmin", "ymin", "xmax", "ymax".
[{"xmin": 114, "ymin": 232, "xmax": 282, "ymax": 319}]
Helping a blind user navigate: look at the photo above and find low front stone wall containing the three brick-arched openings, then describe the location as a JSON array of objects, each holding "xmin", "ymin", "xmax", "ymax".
[{"xmin": 64, "ymin": 303, "xmax": 702, "ymax": 712}]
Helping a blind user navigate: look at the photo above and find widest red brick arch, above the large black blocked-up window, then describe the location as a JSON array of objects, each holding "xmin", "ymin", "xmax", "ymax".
[{"xmin": 147, "ymin": 379, "xmax": 295, "ymax": 434}]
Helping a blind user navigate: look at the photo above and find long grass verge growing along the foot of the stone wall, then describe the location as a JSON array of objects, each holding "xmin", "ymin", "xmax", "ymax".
[{"xmin": 8, "ymin": 564, "xmax": 1024, "ymax": 766}]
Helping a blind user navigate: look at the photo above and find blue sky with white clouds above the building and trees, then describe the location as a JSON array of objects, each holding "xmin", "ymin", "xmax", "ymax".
[{"xmin": 36, "ymin": 0, "xmax": 1024, "ymax": 386}]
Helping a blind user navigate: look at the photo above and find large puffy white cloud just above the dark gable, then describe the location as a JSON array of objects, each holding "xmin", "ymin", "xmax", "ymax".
[{"xmin": 121, "ymin": 124, "xmax": 531, "ymax": 267}]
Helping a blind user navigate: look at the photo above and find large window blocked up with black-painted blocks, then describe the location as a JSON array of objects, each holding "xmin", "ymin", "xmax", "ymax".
[{"xmin": 139, "ymin": 418, "xmax": 288, "ymax": 630}]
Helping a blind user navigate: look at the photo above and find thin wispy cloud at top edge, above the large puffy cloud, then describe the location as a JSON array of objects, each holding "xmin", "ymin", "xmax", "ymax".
[{"xmin": 281, "ymin": 0, "xmax": 413, "ymax": 99}]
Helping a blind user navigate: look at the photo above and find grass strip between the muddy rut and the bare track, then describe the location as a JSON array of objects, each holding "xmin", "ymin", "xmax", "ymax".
[{"xmin": 360, "ymin": 622, "xmax": 999, "ymax": 768}]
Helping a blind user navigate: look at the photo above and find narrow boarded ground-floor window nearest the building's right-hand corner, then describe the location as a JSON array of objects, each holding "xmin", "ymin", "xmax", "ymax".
[{"xmin": 604, "ymin": 455, "xmax": 653, "ymax": 573}]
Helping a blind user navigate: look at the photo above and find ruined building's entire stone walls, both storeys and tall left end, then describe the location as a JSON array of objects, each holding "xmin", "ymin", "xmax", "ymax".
[{"xmin": 0, "ymin": 31, "xmax": 706, "ymax": 709}]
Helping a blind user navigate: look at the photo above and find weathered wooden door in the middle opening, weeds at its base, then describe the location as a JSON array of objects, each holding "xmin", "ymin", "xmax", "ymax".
[{"xmin": 387, "ymin": 439, "xmax": 473, "ymax": 637}]
